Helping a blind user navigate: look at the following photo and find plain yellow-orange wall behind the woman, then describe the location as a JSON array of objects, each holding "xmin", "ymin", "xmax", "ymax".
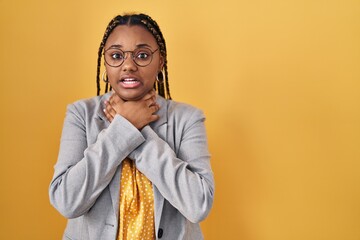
[{"xmin": 0, "ymin": 0, "xmax": 360, "ymax": 240}]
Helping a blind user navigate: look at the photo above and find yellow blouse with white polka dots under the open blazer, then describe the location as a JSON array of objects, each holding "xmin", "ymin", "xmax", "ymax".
[{"xmin": 117, "ymin": 158, "xmax": 155, "ymax": 240}]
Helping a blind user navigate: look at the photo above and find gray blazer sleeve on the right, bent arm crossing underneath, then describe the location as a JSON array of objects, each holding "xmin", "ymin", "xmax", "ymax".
[{"xmin": 129, "ymin": 108, "xmax": 214, "ymax": 223}]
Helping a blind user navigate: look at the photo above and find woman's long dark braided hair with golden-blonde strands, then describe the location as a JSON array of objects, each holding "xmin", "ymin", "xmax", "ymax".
[{"xmin": 96, "ymin": 14, "xmax": 171, "ymax": 99}]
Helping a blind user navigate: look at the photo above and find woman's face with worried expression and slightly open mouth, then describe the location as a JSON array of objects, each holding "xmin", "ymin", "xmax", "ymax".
[{"xmin": 104, "ymin": 25, "xmax": 163, "ymax": 101}]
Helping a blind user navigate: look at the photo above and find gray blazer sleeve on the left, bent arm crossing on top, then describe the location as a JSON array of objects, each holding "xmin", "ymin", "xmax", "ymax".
[{"xmin": 49, "ymin": 104, "xmax": 145, "ymax": 218}]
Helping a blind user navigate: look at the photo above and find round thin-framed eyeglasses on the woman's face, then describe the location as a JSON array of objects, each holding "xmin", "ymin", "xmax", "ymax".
[{"xmin": 104, "ymin": 47, "xmax": 159, "ymax": 67}]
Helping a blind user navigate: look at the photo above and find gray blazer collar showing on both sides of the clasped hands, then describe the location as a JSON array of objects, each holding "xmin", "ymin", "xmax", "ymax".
[{"xmin": 97, "ymin": 91, "xmax": 168, "ymax": 129}]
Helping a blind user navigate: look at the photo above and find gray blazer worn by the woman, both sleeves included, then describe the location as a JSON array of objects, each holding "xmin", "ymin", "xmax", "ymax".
[{"xmin": 49, "ymin": 93, "xmax": 214, "ymax": 240}]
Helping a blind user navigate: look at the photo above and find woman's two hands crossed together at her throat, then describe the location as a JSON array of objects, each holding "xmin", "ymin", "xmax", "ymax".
[{"xmin": 104, "ymin": 90, "xmax": 160, "ymax": 129}]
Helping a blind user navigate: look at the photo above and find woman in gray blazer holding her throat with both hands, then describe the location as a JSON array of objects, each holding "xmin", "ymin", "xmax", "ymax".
[{"xmin": 49, "ymin": 14, "xmax": 214, "ymax": 240}]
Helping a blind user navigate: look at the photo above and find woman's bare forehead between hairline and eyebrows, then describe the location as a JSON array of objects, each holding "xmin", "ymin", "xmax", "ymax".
[{"xmin": 105, "ymin": 25, "xmax": 157, "ymax": 49}]
